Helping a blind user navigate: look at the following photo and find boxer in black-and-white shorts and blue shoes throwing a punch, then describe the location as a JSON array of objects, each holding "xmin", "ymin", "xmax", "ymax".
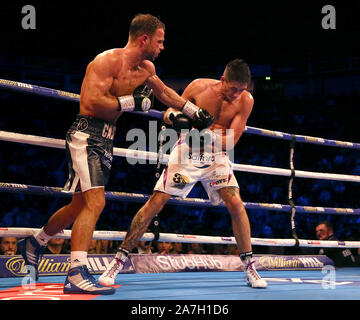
[{"xmin": 19, "ymin": 14, "xmax": 212, "ymax": 294}]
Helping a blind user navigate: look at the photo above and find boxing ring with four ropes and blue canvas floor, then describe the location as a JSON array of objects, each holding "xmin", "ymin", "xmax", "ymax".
[{"xmin": 0, "ymin": 79, "xmax": 360, "ymax": 302}]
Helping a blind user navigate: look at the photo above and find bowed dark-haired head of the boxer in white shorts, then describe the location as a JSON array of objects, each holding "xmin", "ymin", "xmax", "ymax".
[{"xmin": 220, "ymin": 59, "xmax": 251, "ymax": 101}]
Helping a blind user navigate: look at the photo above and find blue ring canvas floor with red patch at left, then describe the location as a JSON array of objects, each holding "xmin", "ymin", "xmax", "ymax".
[{"xmin": 0, "ymin": 268, "xmax": 360, "ymax": 305}]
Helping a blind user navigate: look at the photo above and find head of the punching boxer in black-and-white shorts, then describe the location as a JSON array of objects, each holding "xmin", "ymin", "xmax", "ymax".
[{"xmin": 129, "ymin": 14, "xmax": 165, "ymax": 61}]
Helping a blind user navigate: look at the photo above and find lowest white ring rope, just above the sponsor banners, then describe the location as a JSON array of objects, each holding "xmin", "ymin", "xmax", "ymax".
[{"xmin": 0, "ymin": 228, "xmax": 360, "ymax": 248}]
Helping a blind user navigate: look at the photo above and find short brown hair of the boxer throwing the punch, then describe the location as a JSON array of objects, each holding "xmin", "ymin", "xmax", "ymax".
[{"xmin": 129, "ymin": 14, "xmax": 165, "ymax": 39}]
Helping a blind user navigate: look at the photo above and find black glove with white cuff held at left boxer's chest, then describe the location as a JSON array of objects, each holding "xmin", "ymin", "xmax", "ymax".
[{"xmin": 117, "ymin": 85, "xmax": 154, "ymax": 112}]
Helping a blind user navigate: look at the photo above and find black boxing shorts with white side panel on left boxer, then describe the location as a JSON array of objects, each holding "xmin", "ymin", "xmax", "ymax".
[{"xmin": 64, "ymin": 114, "xmax": 116, "ymax": 192}]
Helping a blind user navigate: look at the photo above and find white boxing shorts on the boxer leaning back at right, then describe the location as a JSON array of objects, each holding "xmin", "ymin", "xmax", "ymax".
[{"xmin": 154, "ymin": 136, "xmax": 239, "ymax": 205}]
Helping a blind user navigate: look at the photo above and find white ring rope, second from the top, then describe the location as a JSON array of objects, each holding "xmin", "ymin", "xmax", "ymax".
[{"xmin": 0, "ymin": 131, "xmax": 360, "ymax": 182}]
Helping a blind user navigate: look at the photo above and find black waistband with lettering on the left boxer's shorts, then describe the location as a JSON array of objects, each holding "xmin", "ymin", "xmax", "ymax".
[{"xmin": 72, "ymin": 114, "xmax": 116, "ymax": 140}]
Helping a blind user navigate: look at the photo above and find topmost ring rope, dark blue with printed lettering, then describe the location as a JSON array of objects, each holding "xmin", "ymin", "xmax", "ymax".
[{"xmin": 0, "ymin": 79, "xmax": 360, "ymax": 149}]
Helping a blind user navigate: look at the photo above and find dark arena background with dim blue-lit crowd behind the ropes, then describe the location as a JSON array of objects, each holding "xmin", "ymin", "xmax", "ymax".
[{"xmin": 0, "ymin": 1, "xmax": 360, "ymax": 254}]
